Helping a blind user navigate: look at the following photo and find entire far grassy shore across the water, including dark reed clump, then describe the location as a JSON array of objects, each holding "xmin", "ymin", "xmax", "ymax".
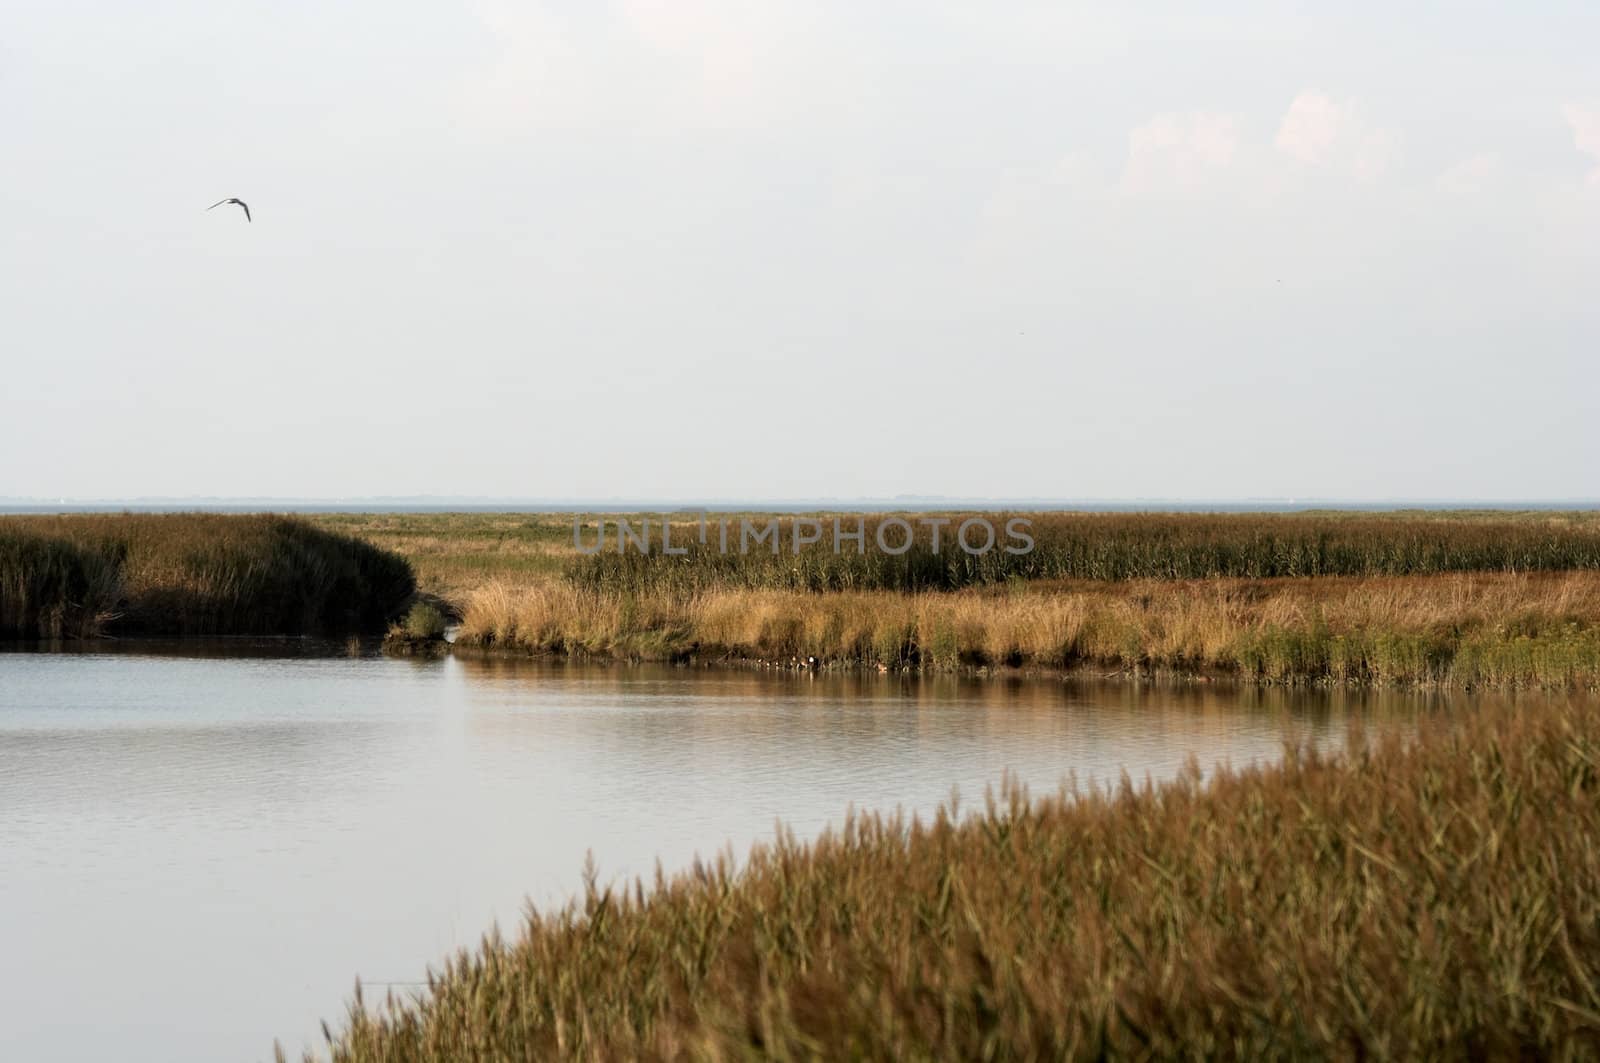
[{"xmin": 12, "ymin": 512, "xmax": 1600, "ymax": 688}]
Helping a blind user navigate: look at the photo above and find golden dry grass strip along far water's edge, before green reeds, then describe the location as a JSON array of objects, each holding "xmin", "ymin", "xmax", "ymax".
[{"xmin": 458, "ymin": 572, "xmax": 1600, "ymax": 688}]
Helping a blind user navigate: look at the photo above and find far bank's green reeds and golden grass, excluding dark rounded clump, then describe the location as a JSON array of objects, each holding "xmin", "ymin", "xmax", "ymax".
[{"xmin": 291, "ymin": 512, "xmax": 1600, "ymax": 688}]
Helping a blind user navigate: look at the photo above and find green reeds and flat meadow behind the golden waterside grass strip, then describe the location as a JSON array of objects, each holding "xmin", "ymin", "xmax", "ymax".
[{"xmin": 307, "ymin": 511, "xmax": 1600, "ymax": 605}]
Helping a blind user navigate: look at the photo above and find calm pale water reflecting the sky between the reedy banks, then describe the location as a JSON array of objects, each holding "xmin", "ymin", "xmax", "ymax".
[{"xmin": 0, "ymin": 645, "xmax": 1418, "ymax": 1061}]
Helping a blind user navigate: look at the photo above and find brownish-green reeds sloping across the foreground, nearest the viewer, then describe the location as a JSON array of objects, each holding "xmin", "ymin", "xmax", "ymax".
[{"xmin": 300, "ymin": 698, "xmax": 1600, "ymax": 1063}]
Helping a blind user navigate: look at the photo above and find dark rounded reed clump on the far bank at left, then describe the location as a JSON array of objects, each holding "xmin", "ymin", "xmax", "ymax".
[{"xmin": 0, "ymin": 514, "xmax": 416, "ymax": 639}]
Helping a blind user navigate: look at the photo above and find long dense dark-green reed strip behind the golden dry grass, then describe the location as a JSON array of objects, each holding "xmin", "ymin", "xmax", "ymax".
[{"xmin": 568, "ymin": 514, "xmax": 1600, "ymax": 591}]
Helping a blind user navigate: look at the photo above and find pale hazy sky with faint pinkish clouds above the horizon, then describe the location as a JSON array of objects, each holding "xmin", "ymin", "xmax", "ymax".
[{"xmin": 0, "ymin": 0, "xmax": 1600, "ymax": 498}]
